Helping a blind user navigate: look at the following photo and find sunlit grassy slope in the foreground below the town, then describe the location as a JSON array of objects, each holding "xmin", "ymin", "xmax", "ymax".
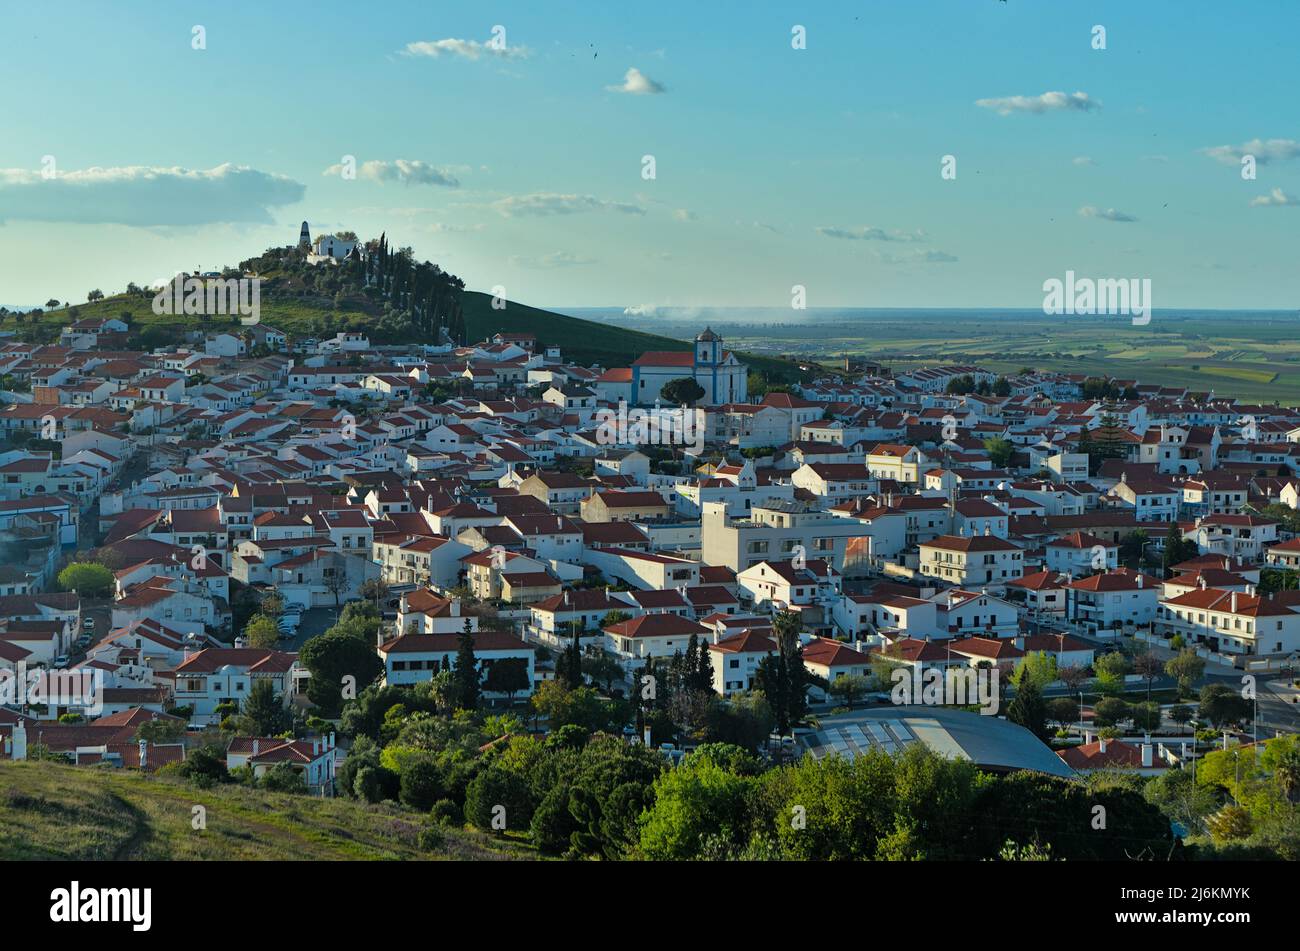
[{"xmin": 0, "ymin": 761, "xmax": 532, "ymax": 861}]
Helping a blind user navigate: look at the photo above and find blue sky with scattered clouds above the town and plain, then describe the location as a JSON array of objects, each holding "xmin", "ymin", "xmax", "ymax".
[{"xmin": 0, "ymin": 0, "xmax": 1300, "ymax": 311}]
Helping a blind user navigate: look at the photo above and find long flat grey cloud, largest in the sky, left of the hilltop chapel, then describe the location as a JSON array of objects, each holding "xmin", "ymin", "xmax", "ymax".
[{"xmin": 0, "ymin": 162, "xmax": 307, "ymax": 227}]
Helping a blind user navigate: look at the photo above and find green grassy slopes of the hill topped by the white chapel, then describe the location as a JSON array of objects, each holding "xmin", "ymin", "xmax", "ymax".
[{"xmin": 0, "ymin": 290, "xmax": 801, "ymax": 383}]
